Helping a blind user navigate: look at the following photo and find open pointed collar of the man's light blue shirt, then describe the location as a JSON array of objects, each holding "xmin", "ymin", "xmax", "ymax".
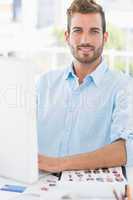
[{"xmin": 64, "ymin": 60, "xmax": 108, "ymax": 87}]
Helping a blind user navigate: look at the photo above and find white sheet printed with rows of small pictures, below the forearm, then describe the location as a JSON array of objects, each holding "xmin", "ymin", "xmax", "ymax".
[{"xmin": 58, "ymin": 167, "xmax": 127, "ymax": 199}]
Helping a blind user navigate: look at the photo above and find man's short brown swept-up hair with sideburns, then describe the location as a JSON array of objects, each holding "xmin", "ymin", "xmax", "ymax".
[{"xmin": 67, "ymin": 0, "xmax": 106, "ymax": 33}]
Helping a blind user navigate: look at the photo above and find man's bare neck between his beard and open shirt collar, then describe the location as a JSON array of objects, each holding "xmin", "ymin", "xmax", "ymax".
[{"xmin": 74, "ymin": 57, "xmax": 102, "ymax": 84}]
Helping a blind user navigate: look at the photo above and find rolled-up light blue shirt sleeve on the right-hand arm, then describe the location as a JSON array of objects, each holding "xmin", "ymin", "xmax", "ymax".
[{"xmin": 110, "ymin": 80, "xmax": 133, "ymax": 166}]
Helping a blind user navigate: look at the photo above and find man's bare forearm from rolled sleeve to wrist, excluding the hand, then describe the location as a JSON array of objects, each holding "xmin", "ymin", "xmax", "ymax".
[{"xmin": 62, "ymin": 140, "xmax": 126, "ymax": 170}]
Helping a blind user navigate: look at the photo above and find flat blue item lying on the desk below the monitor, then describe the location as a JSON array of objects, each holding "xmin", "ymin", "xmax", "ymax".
[{"xmin": 0, "ymin": 185, "xmax": 26, "ymax": 193}]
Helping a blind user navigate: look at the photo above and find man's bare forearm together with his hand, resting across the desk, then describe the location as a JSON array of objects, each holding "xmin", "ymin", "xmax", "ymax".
[{"xmin": 38, "ymin": 140, "xmax": 127, "ymax": 172}]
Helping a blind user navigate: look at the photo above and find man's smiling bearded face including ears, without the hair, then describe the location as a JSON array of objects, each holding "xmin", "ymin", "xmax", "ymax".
[{"xmin": 66, "ymin": 13, "xmax": 108, "ymax": 64}]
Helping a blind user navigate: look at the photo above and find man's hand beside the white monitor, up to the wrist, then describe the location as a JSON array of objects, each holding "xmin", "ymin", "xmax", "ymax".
[{"xmin": 38, "ymin": 154, "xmax": 63, "ymax": 172}]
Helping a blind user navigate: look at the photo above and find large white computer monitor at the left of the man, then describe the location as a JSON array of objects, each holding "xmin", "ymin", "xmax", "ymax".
[{"xmin": 0, "ymin": 58, "xmax": 38, "ymax": 184}]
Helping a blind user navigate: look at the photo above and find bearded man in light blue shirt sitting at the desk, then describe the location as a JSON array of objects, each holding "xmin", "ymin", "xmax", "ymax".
[{"xmin": 37, "ymin": 0, "xmax": 133, "ymax": 172}]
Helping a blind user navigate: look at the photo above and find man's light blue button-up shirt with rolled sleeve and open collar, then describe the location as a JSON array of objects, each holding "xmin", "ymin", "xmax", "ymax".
[{"xmin": 37, "ymin": 62, "xmax": 133, "ymax": 165}]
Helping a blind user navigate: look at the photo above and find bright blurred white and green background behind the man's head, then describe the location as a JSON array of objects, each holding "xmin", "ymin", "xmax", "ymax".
[{"xmin": 0, "ymin": 0, "xmax": 133, "ymax": 75}]
